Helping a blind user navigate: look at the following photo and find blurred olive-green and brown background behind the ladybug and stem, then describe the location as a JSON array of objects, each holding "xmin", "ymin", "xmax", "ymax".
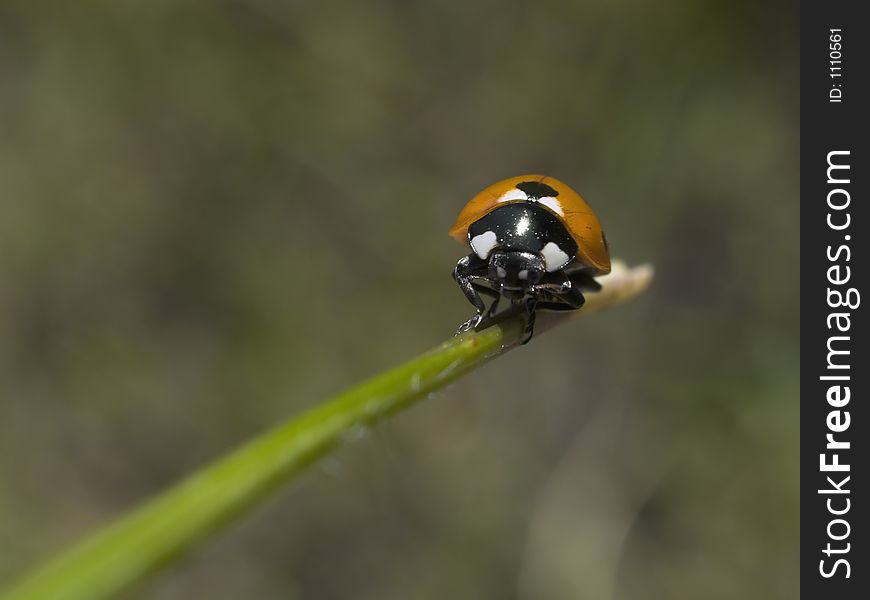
[{"xmin": 0, "ymin": 0, "xmax": 799, "ymax": 600}]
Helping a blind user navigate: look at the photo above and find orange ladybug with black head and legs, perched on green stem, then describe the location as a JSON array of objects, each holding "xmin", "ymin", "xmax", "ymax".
[{"xmin": 450, "ymin": 175, "xmax": 610, "ymax": 344}]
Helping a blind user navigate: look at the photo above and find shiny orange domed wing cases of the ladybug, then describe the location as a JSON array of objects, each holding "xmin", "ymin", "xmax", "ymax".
[{"xmin": 449, "ymin": 175, "xmax": 610, "ymax": 275}]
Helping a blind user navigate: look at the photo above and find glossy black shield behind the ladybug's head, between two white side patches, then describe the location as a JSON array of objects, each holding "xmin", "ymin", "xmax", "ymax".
[{"xmin": 468, "ymin": 202, "xmax": 577, "ymax": 259}]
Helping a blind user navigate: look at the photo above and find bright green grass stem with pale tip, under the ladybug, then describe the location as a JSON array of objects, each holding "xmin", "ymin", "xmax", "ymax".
[{"xmin": 0, "ymin": 267, "xmax": 651, "ymax": 600}]
